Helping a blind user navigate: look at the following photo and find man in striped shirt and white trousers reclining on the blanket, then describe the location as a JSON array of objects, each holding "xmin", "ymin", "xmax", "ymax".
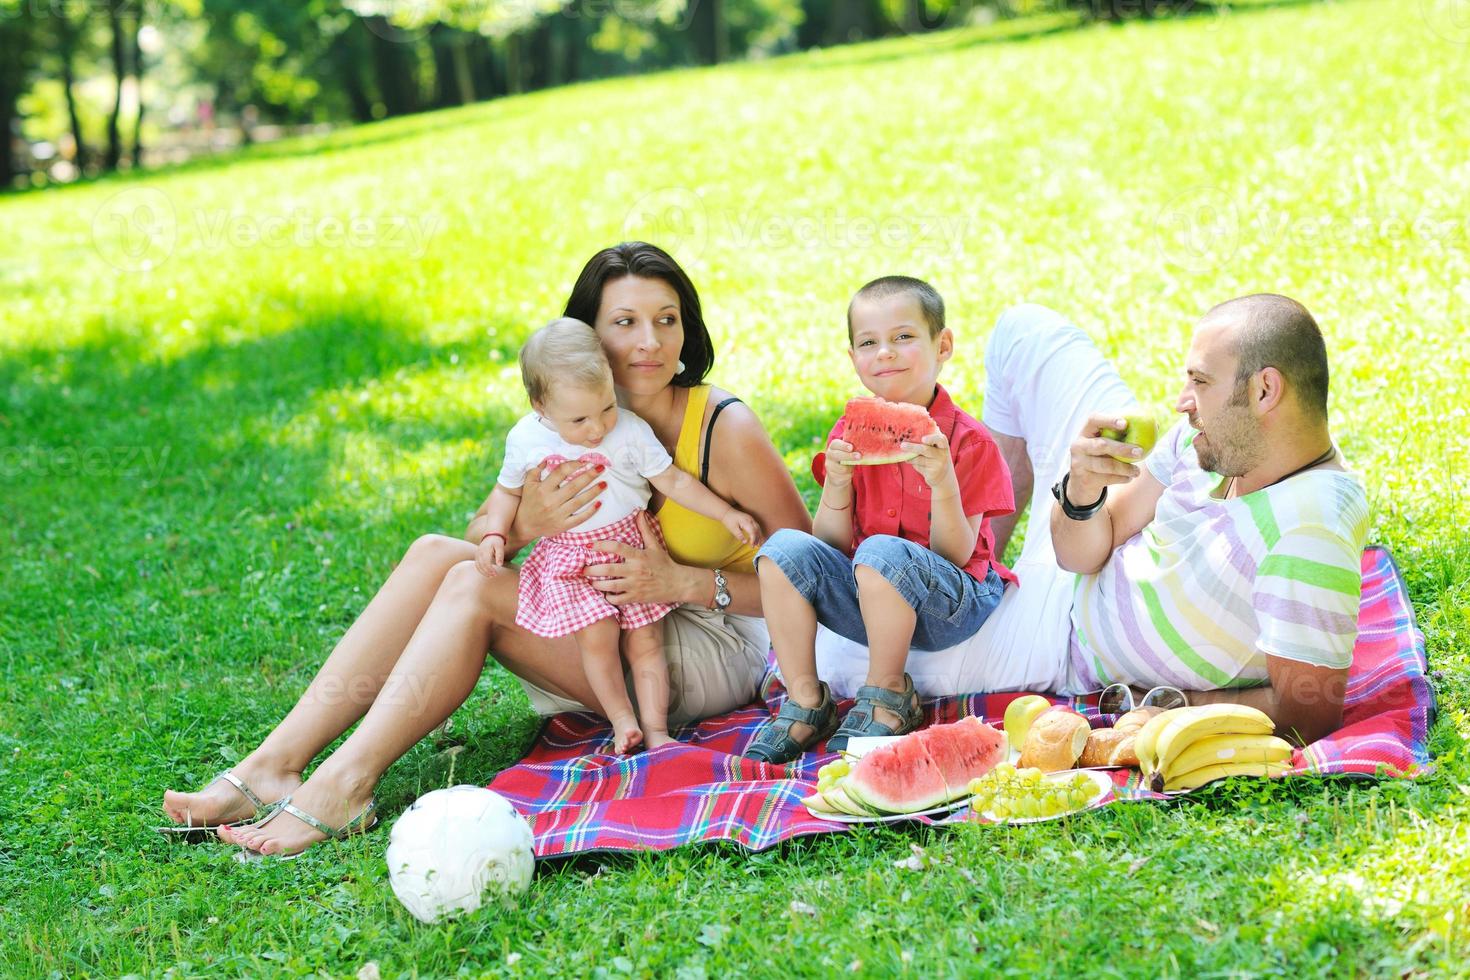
[{"xmin": 819, "ymin": 294, "xmax": 1369, "ymax": 742}]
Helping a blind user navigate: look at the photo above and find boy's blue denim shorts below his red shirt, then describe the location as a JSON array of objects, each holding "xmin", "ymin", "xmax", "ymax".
[{"xmin": 756, "ymin": 527, "xmax": 1005, "ymax": 651}]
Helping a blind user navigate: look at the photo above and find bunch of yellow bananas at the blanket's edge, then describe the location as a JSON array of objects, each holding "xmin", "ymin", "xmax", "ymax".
[{"xmin": 1133, "ymin": 704, "xmax": 1292, "ymax": 792}]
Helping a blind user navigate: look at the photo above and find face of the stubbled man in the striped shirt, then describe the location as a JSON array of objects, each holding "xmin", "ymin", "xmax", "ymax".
[{"xmin": 1175, "ymin": 322, "xmax": 1264, "ymax": 476}]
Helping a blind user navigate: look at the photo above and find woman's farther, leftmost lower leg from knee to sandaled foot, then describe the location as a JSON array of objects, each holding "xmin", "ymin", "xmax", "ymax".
[{"xmin": 163, "ymin": 535, "xmax": 473, "ymax": 824}]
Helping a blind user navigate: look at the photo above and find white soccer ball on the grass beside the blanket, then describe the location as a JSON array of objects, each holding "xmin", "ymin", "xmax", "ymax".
[{"xmin": 387, "ymin": 786, "xmax": 534, "ymax": 923}]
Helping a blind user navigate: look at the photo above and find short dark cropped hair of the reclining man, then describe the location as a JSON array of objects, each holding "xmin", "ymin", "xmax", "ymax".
[{"xmin": 1204, "ymin": 292, "xmax": 1327, "ymax": 419}]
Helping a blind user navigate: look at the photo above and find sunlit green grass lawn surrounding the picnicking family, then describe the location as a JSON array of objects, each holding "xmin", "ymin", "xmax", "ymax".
[{"xmin": 0, "ymin": 0, "xmax": 1470, "ymax": 977}]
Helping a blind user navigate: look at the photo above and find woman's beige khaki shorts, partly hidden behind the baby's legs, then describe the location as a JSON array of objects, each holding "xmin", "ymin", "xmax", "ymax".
[{"xmin": 516, "ymin": 605, "xmax": 770, "ymax": 727}]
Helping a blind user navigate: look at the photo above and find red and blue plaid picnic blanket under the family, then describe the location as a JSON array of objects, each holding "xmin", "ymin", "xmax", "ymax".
[{"xmin": 490, "ymin": 547, "xmax": 1435, "ymax": 858}]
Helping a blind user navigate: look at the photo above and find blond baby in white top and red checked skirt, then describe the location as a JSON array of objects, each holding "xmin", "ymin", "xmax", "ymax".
[{"xmin": 476, "ymin": 317, "xmax": 760, "ymax": 755}]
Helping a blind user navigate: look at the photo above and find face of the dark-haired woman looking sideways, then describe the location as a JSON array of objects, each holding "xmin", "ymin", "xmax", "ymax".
[{"xmin": 592, "ymin": 276, "xmax": 684, "ymax": 395}]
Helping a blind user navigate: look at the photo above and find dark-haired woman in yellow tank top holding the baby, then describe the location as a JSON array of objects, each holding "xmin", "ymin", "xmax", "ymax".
[{"xmin": 163, "ymin": 242, "xmax": 811, "ymax": 855}]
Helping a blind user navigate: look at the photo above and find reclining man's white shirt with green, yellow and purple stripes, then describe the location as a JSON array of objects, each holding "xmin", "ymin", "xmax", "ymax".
[{"xmin": 1072, "ymin": 422, "xmax": 1369, "ymax": 691}]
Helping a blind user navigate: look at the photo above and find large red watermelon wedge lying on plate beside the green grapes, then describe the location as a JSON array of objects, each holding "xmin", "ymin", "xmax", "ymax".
[{"xmin": 841, "ymin": 718, "xmax": 1007, "ymax": 814}]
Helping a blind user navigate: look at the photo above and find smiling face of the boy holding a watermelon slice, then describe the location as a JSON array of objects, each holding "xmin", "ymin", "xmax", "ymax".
[{"xmin": 848, "ymin": 292, "xmax": 954, "ymax": 408}]
